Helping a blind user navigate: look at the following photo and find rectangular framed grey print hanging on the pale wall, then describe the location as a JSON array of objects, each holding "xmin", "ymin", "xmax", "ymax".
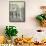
[{"xmin": 9, "ymin": 1, "xmax": 25, "ymax": 22}]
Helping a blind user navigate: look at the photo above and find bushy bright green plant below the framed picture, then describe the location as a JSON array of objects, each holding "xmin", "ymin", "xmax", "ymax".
[{"xmin": 5, "ymin": 26, "xmax": 18, "ymax": 38}]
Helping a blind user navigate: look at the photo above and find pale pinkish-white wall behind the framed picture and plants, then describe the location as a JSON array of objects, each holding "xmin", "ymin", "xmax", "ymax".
[{"xmin": 0, "ymin": 0, "xmax": 46, "ymax": 40}]
